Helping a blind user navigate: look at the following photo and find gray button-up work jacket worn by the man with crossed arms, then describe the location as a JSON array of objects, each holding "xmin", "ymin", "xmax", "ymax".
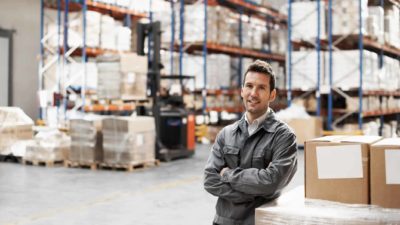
[{"xmin": 204, "ymin": 110, "xmax": 297, "ymax": 225}]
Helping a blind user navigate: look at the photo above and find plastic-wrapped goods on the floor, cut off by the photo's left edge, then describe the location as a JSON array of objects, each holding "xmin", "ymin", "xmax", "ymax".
[{"xmin": 0, "ymin": 107, "xmax": 33, "ymax": 155}]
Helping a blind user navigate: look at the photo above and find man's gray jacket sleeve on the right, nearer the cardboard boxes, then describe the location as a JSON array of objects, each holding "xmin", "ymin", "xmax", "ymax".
[{"xmin": 222, "ymin": 129, "xmax": 297, "ymax": 196}]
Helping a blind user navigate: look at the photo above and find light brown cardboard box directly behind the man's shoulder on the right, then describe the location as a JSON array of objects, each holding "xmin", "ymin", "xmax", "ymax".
[{"xmin": 285, "ymin": 117, "xmax": 322, "ymax": 145}]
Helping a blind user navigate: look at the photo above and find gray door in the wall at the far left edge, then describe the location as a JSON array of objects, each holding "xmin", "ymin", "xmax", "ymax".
[{"xmin": 0, "ymin": 29, "xmax": 12, "ymax": 106}]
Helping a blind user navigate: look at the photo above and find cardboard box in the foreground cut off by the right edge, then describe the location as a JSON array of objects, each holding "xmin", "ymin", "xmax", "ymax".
[{"xmin": 371, "ymin": 138, "xmax": 400, "ymax": 208}]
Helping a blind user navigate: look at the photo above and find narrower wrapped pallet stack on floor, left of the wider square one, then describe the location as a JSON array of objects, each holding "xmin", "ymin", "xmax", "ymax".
[{"xmin": 69, "ymin": 117, "xmax": 103, "ymax": 163}]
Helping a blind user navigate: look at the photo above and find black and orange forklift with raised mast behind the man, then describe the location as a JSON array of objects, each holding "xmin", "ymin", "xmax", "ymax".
[{"xmin": 136, "ymin": 22, "xmax": 195, "ymax": 161}]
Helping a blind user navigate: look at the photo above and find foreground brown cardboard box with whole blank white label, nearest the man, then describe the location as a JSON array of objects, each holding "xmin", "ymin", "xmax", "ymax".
[{"xmin": 304, "ymin": 136, "xmax": 381, "ymax": 204}]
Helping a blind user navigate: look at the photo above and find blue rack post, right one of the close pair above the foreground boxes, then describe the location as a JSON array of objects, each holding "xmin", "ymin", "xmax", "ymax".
[{"xmin": 327, "ymin": 0, "xmax": 333, "ymax": 130}]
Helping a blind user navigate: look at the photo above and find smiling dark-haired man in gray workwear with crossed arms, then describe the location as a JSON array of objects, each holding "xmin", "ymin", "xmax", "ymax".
[{"xmin": 204, "ymin": 60, "xmax": 297, "ymax": 225}]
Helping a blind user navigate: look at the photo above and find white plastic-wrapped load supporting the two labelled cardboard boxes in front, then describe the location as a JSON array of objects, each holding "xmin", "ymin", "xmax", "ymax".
[{"xmin": 255, "ymin": 186, "xmax": 400, "ymax": 225}]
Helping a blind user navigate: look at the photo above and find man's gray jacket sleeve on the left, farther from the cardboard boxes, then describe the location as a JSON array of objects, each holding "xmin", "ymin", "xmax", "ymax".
[{"xmin": 204, "ymin": 130, "xmax": 254, "ymax": 203}]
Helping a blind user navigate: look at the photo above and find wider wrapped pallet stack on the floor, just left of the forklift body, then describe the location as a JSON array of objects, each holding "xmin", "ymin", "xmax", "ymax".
[{"xmin": 103, "ymin": 117, "xmax": 155, "ymax": 164}]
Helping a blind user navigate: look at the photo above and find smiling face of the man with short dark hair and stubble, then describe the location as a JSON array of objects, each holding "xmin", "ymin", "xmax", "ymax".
[{"xmin": 241, "ymin": 71, "xmax": 276, "ymax": 120}]
